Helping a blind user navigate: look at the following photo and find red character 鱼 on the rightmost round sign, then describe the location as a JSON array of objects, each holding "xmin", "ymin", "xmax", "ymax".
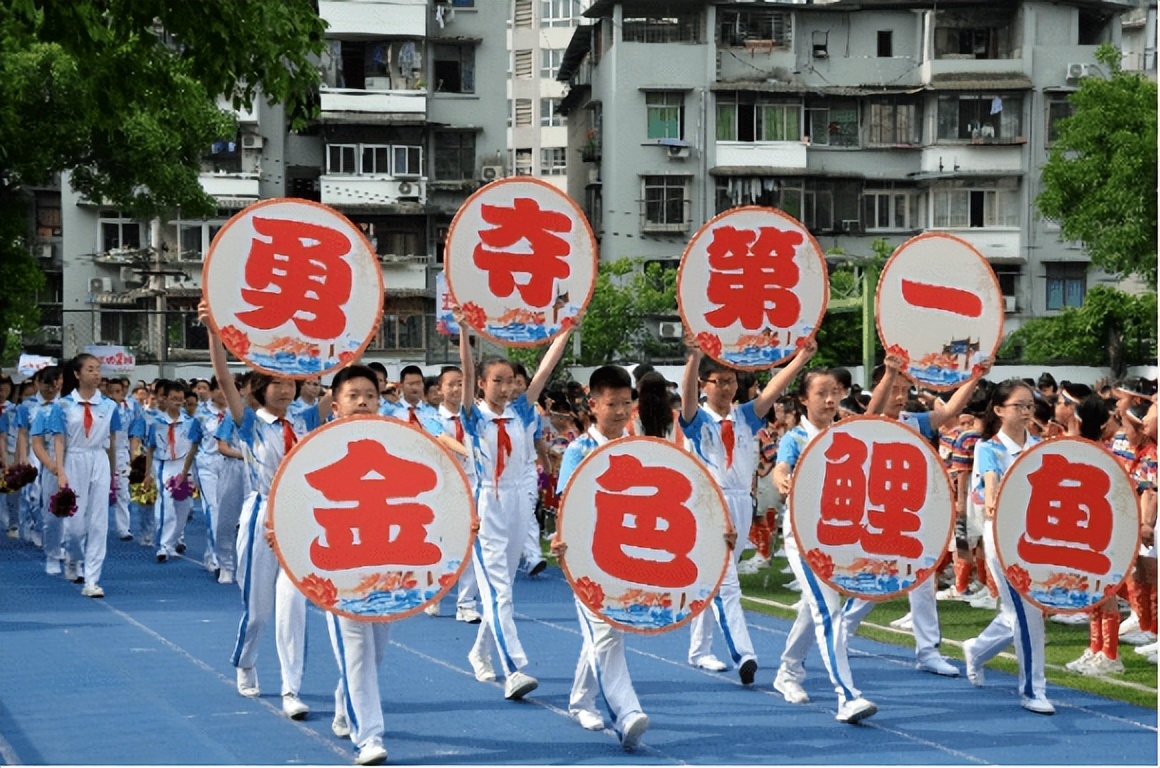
[{"xmin": 1016, "ymin": 454, "xmax": 1112, "ymax": 574}]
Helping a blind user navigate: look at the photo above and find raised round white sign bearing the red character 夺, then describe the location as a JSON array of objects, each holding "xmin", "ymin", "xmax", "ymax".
[{"xmin": 444, "ymin": 177, "xmax": 596, "ymax": 347}]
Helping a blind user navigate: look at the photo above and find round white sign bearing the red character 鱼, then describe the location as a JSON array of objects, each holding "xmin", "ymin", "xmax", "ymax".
[{"xmin": 994, "ymin": 437, "xmax": 1140, "ymax": 614}]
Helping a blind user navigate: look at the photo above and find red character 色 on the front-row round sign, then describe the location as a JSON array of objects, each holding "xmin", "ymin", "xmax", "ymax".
[{"xmin": 592, "ymin": 455, "xmax": 697, "ymax": 588}]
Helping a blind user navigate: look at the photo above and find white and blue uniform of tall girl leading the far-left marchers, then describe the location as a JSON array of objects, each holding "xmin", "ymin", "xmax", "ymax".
[{"xmin": 32, "ymin": 390, "xmax": 121, "ymax": 588}]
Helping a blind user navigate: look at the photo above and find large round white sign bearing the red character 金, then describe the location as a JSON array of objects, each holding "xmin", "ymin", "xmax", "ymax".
[{"xmin": 267, "ymin": 416, "xmax": 476, "ymax": 622}]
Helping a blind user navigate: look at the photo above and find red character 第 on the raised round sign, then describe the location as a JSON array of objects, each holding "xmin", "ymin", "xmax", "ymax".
[{"xmin": 705, "ymin": 226, "xmax": 805, "ymax": 331}]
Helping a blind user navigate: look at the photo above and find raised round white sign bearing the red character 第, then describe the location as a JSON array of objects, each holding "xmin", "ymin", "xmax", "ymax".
[{"xmin": 676, "ymin": 205, "xmax": 829, "ymax": 370}]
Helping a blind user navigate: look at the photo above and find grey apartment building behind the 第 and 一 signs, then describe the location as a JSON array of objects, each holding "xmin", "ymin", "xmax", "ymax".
[{"xmin": 558, "ymin": 0, "xmax": 1155, "ymax": 341}]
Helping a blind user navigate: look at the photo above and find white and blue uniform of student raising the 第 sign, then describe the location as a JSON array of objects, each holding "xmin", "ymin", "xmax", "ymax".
[{"xmin": 680, "ymin": 400, "xmax": 763, "ymax": 672}]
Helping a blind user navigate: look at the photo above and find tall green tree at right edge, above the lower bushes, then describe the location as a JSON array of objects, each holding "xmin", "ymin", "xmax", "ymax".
[{"xmin": 1037, "ymin": 45, "xmax": 1157, "ymax": 284}]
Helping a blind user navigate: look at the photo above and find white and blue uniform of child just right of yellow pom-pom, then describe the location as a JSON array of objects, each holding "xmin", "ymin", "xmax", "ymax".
[{"xmin": 145, "ymin": 410, "xmax": 202, "ymax": 558}]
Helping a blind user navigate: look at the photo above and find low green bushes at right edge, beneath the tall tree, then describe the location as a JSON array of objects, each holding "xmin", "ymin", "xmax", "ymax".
[{"xmin": 999, "ymin": 285, "xmax": 1157, "ymax": 376}]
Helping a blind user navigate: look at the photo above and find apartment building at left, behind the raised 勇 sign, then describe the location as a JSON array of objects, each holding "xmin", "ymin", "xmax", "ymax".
[{"xmin": 45, "ymin": 0, "xmax": 512, "ymax": 363}]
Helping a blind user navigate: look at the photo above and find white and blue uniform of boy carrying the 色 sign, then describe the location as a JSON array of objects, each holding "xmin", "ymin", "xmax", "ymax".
[{"xmin": 557, "ymin": 427, "xmax": 640, "ymax": 736}]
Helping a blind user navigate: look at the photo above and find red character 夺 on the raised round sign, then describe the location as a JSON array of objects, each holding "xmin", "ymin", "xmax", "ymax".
[{"xmin": 474, "ymin": 197, "xmax": 572, "ymax": 306}]
